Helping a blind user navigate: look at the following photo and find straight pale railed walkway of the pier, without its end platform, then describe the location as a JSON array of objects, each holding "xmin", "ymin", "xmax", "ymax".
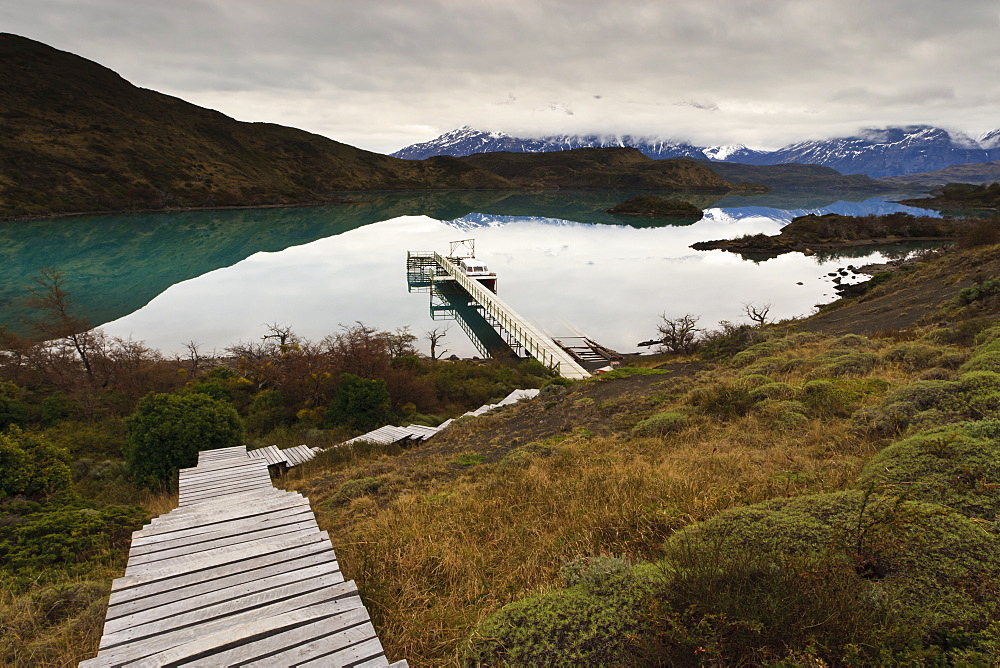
[{"xmin": 434, "ymin": 253, "xmax": 590, "ymax": 379}]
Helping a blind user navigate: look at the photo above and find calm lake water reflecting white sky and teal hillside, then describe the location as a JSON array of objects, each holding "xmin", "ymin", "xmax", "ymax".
[{"xmin": 0, "ymin": 193, "xmax": 926, "ymax": 355}]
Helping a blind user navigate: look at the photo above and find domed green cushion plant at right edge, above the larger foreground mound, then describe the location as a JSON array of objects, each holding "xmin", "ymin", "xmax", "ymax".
[{"xmin": 857, "ymin": 420, "xmax": 1000, "ymax": 522}]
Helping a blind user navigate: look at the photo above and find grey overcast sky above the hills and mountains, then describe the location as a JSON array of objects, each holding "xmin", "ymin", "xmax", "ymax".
[{"xmin": 0, "ymin": 0, "xmax": 1000, "ymax": 152}]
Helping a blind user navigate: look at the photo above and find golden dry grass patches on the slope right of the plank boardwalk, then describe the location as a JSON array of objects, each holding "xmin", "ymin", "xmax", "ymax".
[{"xmin": 276, "ymin": 339, "xmax": 913, "ymax": 665}]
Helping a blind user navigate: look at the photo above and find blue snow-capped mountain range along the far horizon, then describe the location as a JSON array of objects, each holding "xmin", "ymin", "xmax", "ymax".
[{"xmin": 392, "ymin": 125, "xmax": 1000, "ymax": 178}]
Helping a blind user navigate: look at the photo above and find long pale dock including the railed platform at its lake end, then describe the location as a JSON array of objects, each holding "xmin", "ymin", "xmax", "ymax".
[{"xmin": 406, "ymin": 251, "xmax": 591, "ymax": 380}]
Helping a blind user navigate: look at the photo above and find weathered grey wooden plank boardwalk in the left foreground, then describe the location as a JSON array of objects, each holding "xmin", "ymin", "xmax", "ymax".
[{"xmin": 80, "ymin": 447, "xmax": 407, "ymax": 668}]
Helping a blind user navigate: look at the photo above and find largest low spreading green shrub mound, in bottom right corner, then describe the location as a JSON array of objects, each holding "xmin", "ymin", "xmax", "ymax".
[{"xmin": 663, "ymin": 491, "xmax": 1000, "ymax": 664}]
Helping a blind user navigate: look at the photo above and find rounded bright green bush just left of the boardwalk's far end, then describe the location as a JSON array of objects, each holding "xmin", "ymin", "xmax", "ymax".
[{"xmin": 122, "ymin": 393, "xmax": 243, "ymax": 487}]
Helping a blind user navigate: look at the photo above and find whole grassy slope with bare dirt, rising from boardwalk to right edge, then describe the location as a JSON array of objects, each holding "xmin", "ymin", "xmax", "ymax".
[{"xmin": 276, "ymin": 241, "xmax": 1000, "ymax": 665}]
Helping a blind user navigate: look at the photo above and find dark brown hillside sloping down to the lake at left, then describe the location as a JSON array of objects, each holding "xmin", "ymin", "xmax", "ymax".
[{"xmin": 0, "ymin": 34, "xmax": 511, "ymax": 218}]
